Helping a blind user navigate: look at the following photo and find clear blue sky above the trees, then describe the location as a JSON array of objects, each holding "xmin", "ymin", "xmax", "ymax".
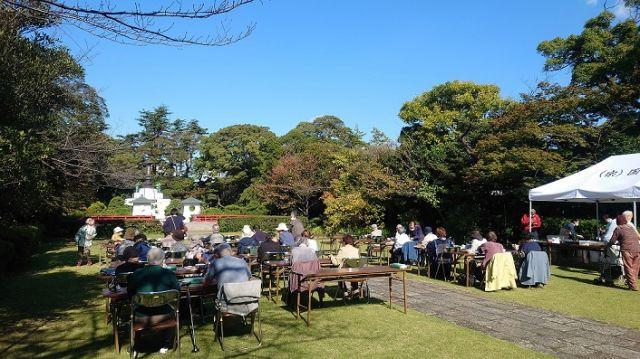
[{"xmin": 59, "ymin": 0, "xmax": 620, "ymax": 138}]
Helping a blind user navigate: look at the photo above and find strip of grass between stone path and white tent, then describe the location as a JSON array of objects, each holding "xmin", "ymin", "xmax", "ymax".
[{"xmin": 411, "ymin": 265, "xmax": 640, "ymax": 329}]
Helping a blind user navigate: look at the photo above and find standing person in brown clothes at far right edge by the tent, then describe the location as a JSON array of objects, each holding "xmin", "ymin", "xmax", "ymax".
[{"xmin": 609, "ymin": 215, "xmax": 640, "ymax": 291}]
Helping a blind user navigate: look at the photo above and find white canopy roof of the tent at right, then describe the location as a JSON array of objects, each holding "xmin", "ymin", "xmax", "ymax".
[{"xmin": 529, "ymin": 153, "xmax": 640, "ymax": 202}]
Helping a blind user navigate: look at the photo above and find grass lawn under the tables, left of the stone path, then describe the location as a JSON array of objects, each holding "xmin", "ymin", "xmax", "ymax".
[{"xmin": 0, "ymin": 244, "xmax": 542, "ymax": 358}]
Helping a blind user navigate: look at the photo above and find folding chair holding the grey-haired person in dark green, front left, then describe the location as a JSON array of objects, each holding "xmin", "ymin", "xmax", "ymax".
[{"xmin": 130, "ymin": 289, "xmax": 180, "ymax": 358}]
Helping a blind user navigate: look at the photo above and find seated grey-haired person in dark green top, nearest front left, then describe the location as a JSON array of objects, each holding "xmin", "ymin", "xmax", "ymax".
[{"xmin": 127, "ymin": 248, "xmax": 180, "ymax": 350}]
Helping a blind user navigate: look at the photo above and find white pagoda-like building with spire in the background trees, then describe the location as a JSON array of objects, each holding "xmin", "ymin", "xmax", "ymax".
[{"xmin": 124, "ymin": 166, "xmax": 171, "ymax": 220}]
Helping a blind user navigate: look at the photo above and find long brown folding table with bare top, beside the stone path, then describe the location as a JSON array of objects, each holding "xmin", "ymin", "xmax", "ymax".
[{"xmin": 292, "ymin": 266, "xmax": 407, "ymax": 326}]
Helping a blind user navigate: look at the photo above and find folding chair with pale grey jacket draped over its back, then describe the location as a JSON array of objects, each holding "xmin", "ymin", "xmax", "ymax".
[{"xmin": 213, "ymin": 280, "xmax": 262, "ymax": 351}]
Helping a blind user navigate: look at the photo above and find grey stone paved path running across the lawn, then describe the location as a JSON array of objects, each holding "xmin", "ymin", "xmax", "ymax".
[{"xmin": 369, "ymin": 279, "xmax": 640, "ymax": 358}]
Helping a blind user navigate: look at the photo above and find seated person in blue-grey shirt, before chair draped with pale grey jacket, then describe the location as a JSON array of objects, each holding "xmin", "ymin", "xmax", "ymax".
[{"xmin": 205, "ymin": 243, "xmax": 251, "ymax": 295}]
